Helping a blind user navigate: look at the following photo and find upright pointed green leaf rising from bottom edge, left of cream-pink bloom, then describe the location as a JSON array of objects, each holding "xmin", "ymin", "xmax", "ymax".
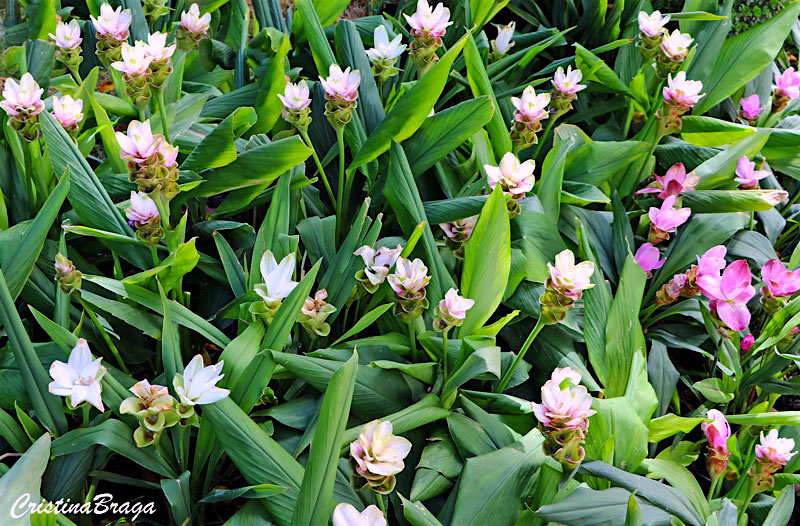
[{"xmin": 292, "ymin": 351, "xmax": 358, "ymax": 526}]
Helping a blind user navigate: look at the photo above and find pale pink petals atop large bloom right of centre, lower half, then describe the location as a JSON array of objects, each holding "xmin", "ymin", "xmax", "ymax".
[{"xmin": 531, "ymin": 371, "xmax": 597, "ymax": 429}]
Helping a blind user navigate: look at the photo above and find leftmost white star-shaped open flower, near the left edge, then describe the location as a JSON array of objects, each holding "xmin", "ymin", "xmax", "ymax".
[{"xmin": 48, "ymin": 338, "xmax": 106, "ymax": 413}]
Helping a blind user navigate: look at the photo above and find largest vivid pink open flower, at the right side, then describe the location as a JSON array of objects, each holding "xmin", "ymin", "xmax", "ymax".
[{"xmin": 697, "ymin": 259, "xmax": 756, "ymax": 331}]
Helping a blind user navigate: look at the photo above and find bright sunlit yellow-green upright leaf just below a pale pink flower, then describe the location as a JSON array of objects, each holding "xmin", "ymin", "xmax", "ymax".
[{"xmin": 459, "ymin": 186, "xmax": 511, "ymax": 337}]
